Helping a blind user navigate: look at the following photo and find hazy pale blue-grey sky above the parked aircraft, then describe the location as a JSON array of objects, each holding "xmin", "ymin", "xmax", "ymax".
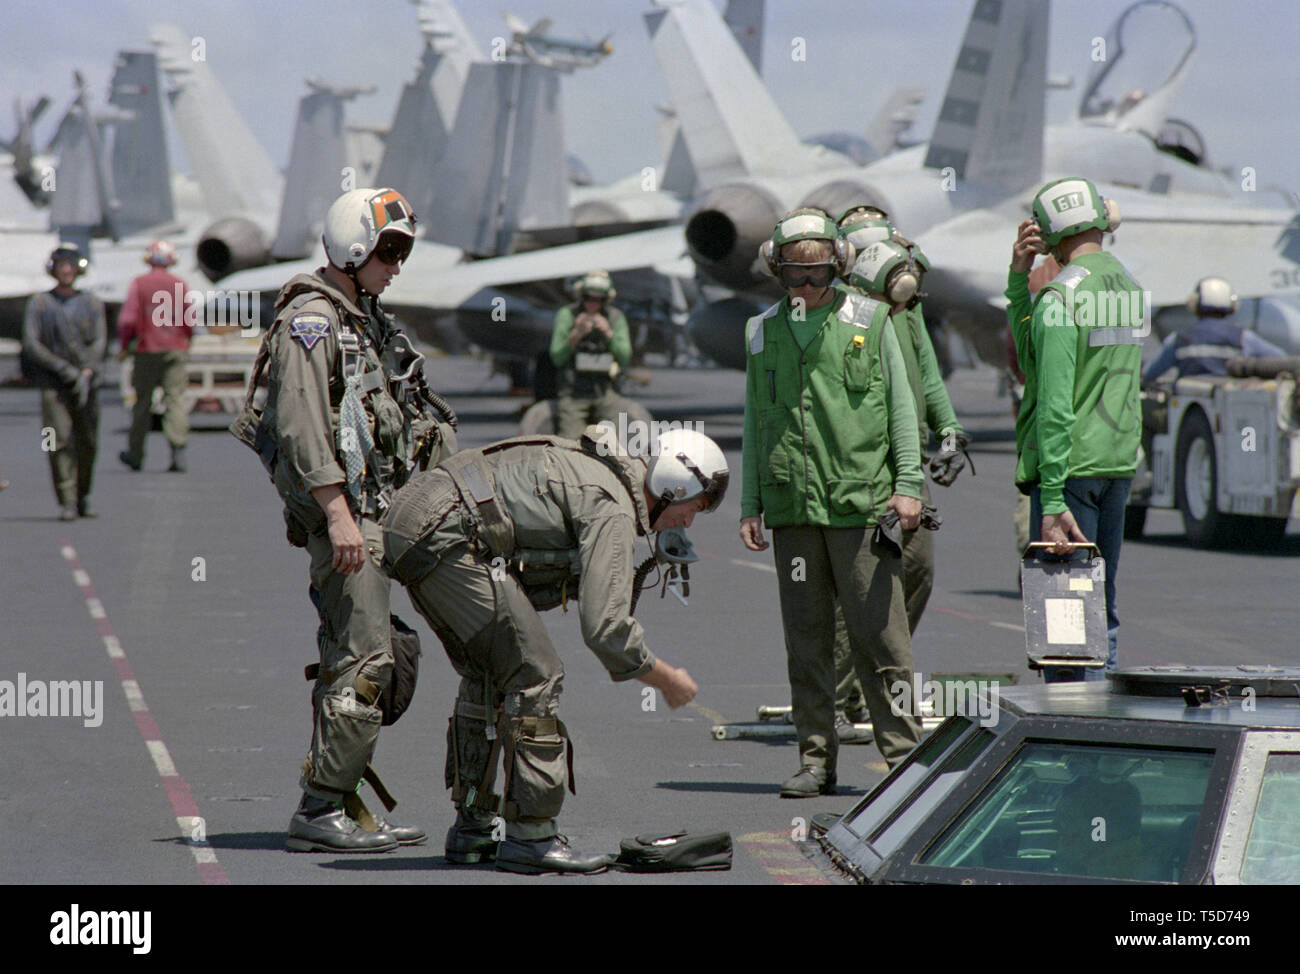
[{"xmin": 0, "ymin": 0, "xmax": 1300, "ymax": 191}]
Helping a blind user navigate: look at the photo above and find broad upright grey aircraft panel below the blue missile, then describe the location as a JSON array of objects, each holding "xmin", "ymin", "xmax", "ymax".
[{"xmin": 426, "ymin": 61, "xmax": 569, "ymax": 256}]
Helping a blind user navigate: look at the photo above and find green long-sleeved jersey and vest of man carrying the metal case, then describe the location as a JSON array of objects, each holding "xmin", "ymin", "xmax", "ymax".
[{"xmin": 1006, "ymin": 251, "xmax": 1149, "ymax": 514}]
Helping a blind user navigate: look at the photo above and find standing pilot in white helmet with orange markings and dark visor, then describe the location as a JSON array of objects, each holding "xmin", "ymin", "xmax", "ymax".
[{"xmin": 231, "ymin": 189, "xmax": 455, "ymax": 852}]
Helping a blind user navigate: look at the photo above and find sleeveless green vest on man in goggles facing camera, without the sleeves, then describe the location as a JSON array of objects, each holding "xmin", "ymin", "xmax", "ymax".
[{"xmin": 745, "ymin": 293, "xmax": 902, "ymax": 528}]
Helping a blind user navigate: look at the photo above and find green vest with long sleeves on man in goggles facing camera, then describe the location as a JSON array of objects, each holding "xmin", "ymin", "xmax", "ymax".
[{"xmin": 741, "ymin": 291, "xmax": 923, "ymax": 528}]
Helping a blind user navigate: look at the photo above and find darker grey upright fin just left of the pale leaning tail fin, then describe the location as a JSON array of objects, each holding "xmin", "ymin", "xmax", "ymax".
[{"xmin": 108, "ymin": 51, "xmax": 176, "ymax": 233}]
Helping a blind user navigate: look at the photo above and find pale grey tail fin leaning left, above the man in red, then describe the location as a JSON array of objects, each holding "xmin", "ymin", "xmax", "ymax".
[{"xmin": 150, "ymin": 25, "xmax": 282, "ymax": 219}]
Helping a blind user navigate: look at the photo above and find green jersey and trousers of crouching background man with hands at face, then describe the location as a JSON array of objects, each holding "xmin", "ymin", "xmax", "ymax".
[{"xmin": 550, "ymin": 304, "xmax": 632, "ymax": 440}]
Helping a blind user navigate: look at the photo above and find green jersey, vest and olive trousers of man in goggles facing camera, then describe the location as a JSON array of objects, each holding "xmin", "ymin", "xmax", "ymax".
[{"xmin": 741, "ymin": 293, "xmax": 923, "ymax": 771}]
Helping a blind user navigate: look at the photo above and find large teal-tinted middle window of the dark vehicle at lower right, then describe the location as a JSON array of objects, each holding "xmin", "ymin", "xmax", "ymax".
[{"xmin": 920, "ymin": 741, "xmax": 1214, "ymax": 882}]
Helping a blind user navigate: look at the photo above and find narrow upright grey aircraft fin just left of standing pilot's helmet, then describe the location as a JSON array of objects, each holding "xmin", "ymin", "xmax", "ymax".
[{"xmin": 270, "ymin": 81, "xmax": 373, "ymax": 260}]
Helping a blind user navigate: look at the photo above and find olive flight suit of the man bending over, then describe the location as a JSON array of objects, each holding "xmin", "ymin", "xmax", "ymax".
[{"xmin": 384, "ymin": 437, "xmax": 655, "ymax": 839}]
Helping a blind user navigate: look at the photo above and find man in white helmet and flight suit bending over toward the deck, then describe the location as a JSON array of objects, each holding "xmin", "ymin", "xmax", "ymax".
[{"xmin": 384, "ymin": 425, "xmax": 729, "ymax": 874}]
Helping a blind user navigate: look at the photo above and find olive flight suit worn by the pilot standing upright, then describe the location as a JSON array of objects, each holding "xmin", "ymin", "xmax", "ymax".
[{"xmin": 263, "ymin": 270, "xmax": 454, "ymax": 801}]
